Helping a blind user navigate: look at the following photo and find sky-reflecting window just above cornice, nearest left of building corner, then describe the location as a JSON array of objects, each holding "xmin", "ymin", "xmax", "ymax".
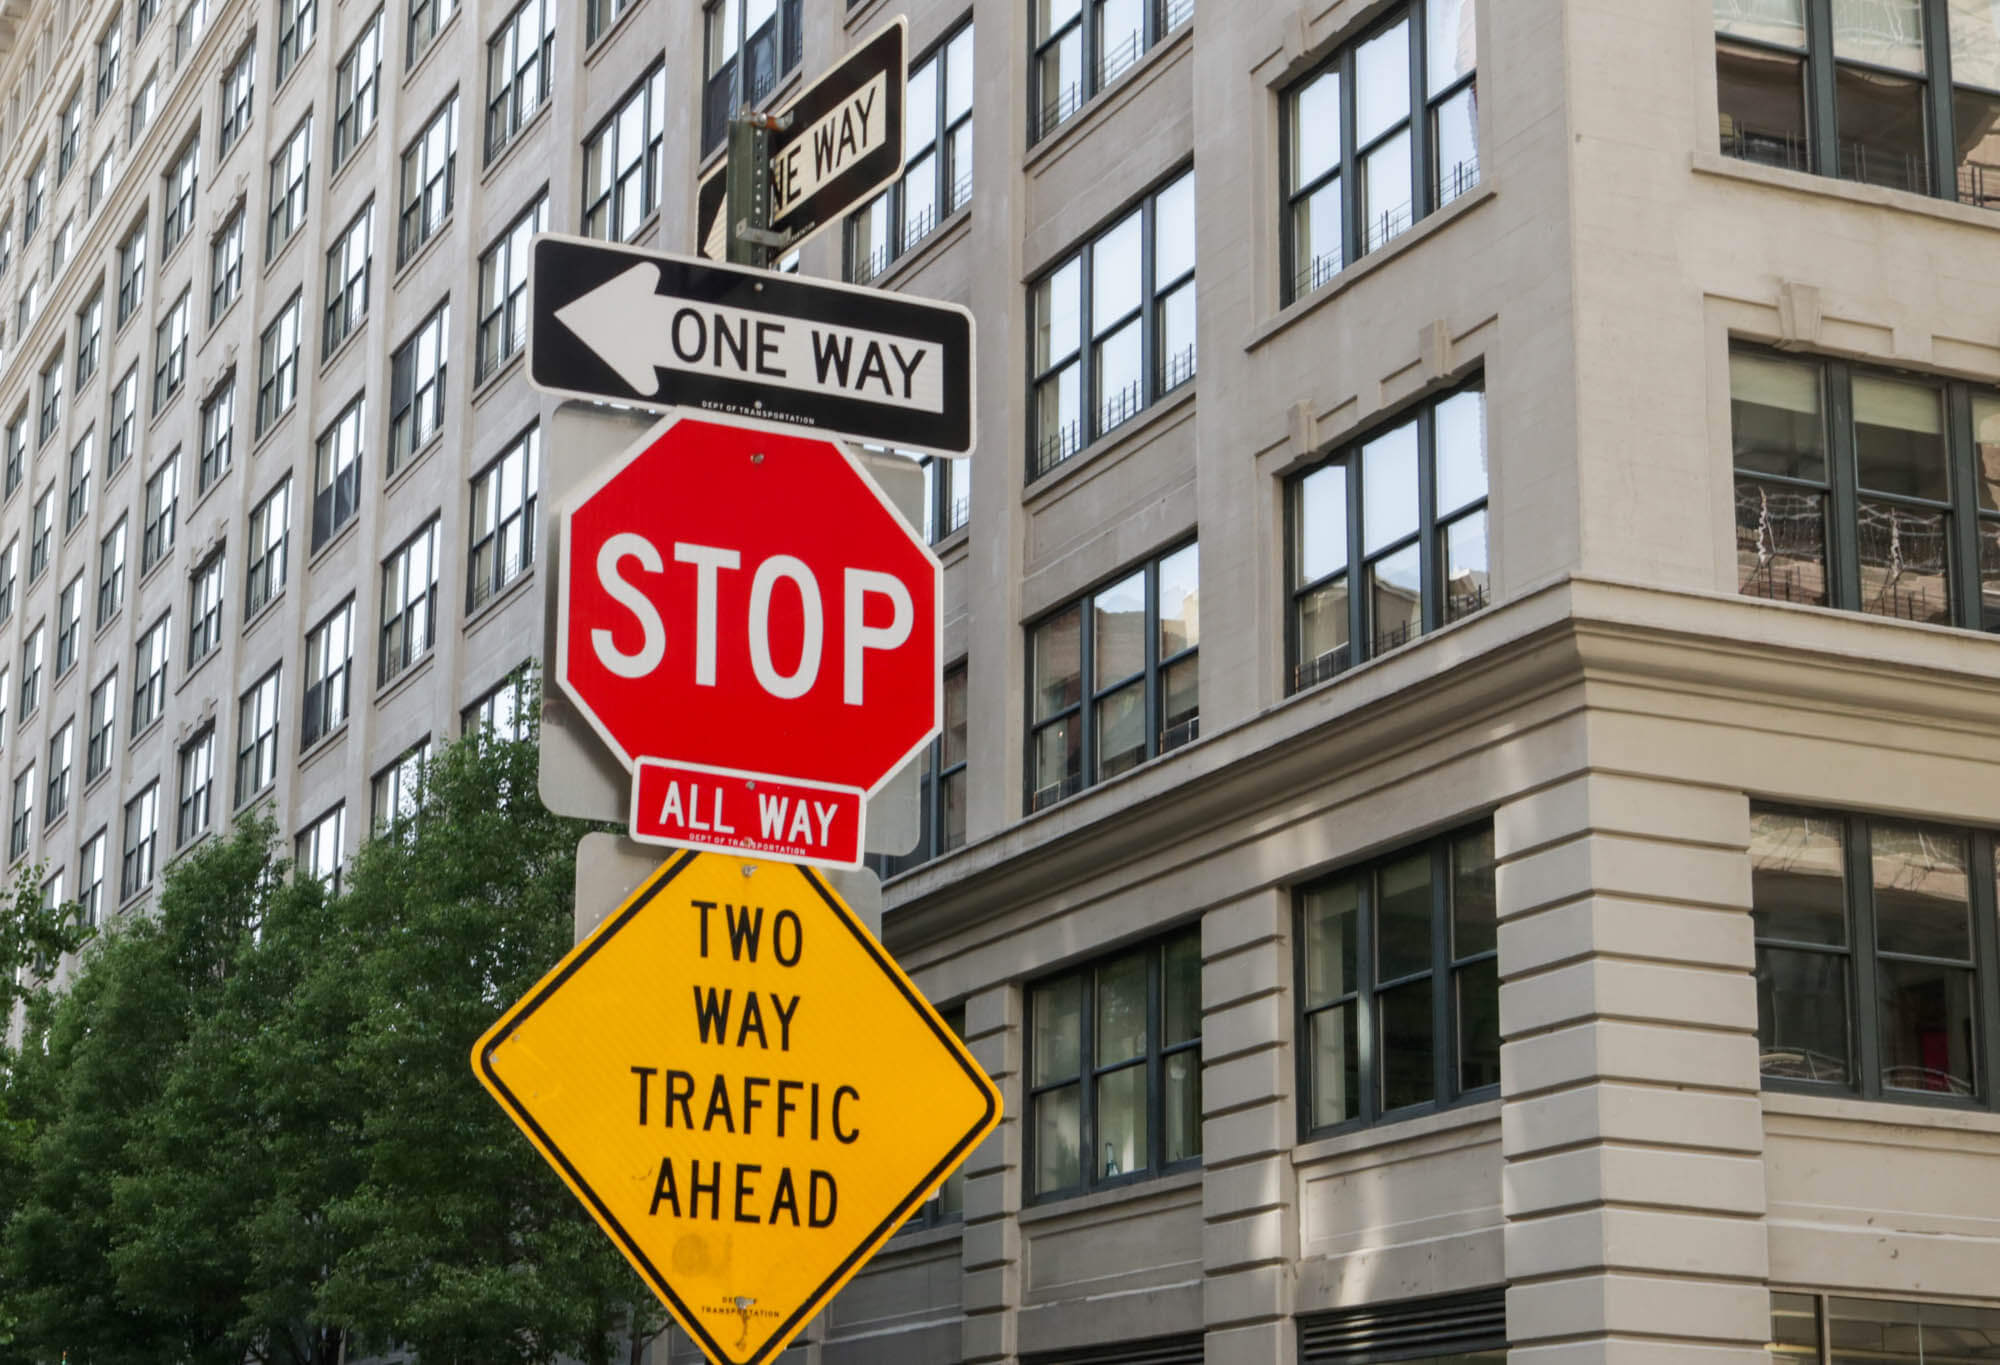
[{"xmin": 1286, "ymin": 386, "xmax": 1490, "ymax": 693}]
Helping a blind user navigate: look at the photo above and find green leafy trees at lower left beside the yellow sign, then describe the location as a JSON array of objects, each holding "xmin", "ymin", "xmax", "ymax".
[{"xmin": 0, "ymin": 716, "xmax": 658, "ymax": 1365}]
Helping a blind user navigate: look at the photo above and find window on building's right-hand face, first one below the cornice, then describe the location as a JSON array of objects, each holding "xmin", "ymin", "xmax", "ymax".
[{"xmin": 1750, "ymin": 805, "xmax": 2000, "ymax": 1107}]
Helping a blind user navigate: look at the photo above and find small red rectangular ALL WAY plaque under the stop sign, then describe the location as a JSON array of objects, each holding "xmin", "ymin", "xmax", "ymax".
[{"xmin": 632, "ymin": 759, "xmax": 864, "ymax": 867}]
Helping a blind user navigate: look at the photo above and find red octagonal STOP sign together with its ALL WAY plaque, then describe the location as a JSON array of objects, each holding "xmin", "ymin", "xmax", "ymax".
[{"xmin": 556, "ymin": 416, "xmax": 944, "ymax": 867}]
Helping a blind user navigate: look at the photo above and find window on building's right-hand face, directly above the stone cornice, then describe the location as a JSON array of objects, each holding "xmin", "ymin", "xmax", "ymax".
[{"xmin": 1730, "ymin": 350, "xmax": 2000, "ymax": 630}]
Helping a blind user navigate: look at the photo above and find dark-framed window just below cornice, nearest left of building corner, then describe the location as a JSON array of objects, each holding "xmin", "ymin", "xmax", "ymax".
[{"xmin": 1298, "ymin": 825, "xmax": 1500, "ymax": 1133}]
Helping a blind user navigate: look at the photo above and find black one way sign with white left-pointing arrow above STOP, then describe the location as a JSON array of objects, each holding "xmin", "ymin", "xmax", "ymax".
[{"xmin": 528, "ymin": 234, "xmax": 972, "ymax": 454}]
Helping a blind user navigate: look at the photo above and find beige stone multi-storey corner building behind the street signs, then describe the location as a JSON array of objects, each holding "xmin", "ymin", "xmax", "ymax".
[{"xmin": 0, "ymin": 0, "xmax": 2000, "ymax": 1365}]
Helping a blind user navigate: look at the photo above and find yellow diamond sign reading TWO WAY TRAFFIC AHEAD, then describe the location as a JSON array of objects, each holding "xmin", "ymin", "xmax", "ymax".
[{"xmin": 472, "ymin": 853, "xmax": 1000, "ymax": 1365}]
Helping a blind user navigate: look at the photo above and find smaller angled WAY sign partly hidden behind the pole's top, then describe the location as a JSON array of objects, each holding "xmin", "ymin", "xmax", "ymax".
[{"xmin": 696, "ymin": 16, "xmax": 910, "ymax": 260}]
